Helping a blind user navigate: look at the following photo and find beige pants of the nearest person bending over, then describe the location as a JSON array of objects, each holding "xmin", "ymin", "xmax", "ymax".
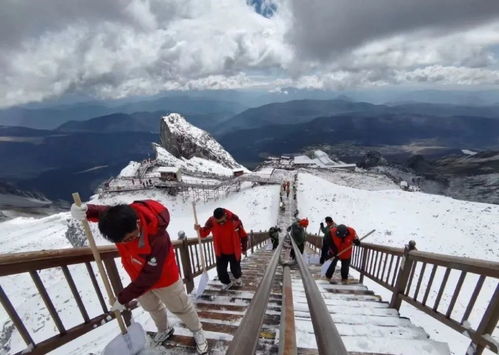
[{"xmin": 137, "ymin": 278, "xmax": 201, "ymax": 332}]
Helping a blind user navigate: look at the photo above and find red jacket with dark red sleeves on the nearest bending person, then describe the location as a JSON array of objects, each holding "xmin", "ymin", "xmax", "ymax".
[{"xmin": 87, "ymin": 200, "xmax": 179, "ymax": 304}]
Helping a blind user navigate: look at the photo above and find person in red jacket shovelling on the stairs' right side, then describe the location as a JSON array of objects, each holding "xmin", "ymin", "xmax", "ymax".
[{"xmin": 326, "ymin": 224, "xmax": 360, "ymax": 283}]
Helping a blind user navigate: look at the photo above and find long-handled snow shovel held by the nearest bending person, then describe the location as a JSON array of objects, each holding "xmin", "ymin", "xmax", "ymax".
[{"xmin": 73, "ymin": 192, "xmax": 146, "ymax": 355}]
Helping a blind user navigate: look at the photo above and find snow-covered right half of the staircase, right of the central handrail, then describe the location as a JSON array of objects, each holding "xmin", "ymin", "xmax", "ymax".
[{"xmin": 292, "ymin": 264, "xmax": 450, "ymax": 355}]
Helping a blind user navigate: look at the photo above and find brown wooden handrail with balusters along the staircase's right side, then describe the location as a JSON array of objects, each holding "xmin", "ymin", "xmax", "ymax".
[{"xmin": 308, "ymin": 235, "xmax": 499, "ymax": 355}]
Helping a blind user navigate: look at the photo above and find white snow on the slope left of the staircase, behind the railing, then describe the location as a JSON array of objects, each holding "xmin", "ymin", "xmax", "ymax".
[{"xmin": 0, "ymin": 186, "xmax": 279, "ymax": 354}]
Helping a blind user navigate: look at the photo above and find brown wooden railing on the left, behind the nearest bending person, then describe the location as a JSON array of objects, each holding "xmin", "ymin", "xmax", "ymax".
[{"xmin": 0, "ymin": 232, "xmax": 269, "ymax": 354}]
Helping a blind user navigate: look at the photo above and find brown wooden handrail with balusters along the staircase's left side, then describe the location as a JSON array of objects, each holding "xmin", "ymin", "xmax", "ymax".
[{"xmin": 0, "ymin": 232, "xmax": 269, "ymax": 354}]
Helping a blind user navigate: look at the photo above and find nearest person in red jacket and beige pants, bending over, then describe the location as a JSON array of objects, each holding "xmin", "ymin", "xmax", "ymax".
[{"xmin": 71, "ymin": 200, "xmax": 208, "ymax": 354}]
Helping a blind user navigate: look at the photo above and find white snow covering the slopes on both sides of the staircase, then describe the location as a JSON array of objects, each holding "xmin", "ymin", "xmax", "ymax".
[{"xmin": 0, "ymin": 171, "xmax": 499, "ymax": 354}]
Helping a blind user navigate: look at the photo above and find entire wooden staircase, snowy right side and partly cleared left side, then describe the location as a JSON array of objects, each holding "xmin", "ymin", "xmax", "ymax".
[{"xmin": 140, "ymin": 244, "xmax": 450, "ymax": 355}]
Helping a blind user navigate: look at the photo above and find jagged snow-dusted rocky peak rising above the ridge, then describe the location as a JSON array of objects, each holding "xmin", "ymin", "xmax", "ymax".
[{"xmin": 160, "ymin": 113, "xmax": 243, "ymax": 169}]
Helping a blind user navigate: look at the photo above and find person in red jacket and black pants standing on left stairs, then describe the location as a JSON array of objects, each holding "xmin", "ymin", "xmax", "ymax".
[{"xmin": 194, "ymin": 207, "xmax": 248, "ymax": 289}]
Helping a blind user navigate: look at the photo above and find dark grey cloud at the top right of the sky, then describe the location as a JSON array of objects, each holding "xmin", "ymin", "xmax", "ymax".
[{"xmin": 286, "ymin": 0, "xmax": 499, "ymax": 60}]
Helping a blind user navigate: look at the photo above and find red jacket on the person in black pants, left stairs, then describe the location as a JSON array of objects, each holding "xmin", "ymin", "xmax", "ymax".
[{"xmin": 199, "ymin": 209, "xmax": 248, "ymax": 260}]
